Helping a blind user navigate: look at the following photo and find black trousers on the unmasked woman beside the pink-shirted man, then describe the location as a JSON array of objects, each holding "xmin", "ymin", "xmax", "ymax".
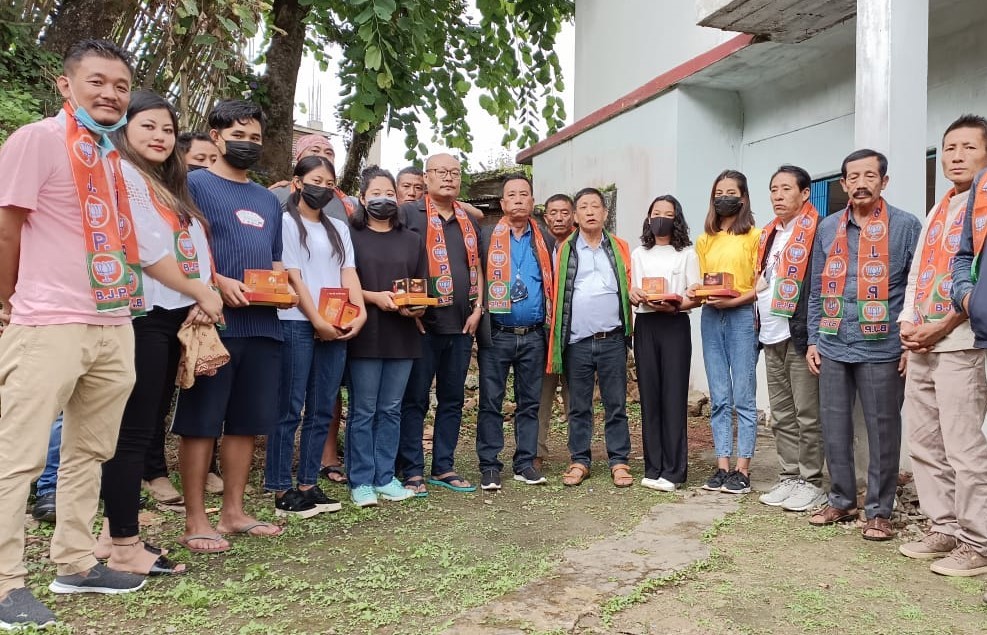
[{"xmin": 102, "ymin": 307, "xmax": 189, "ymax": 538}]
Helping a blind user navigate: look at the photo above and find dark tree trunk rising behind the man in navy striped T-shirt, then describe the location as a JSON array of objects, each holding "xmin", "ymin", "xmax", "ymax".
[{"xmin": 257, "ymin": 0, "xmax": 310, "ymax": 181}]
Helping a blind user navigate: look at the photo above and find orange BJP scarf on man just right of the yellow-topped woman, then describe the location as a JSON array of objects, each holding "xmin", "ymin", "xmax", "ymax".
[{"xmin": 757, "ymin": 201, "xmax": 819, "ymax": 318}]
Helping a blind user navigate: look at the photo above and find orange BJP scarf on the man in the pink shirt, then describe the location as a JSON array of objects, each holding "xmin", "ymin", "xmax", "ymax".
[{"xmin": 64, "ymin": 103, "xmax": 147, "ymax": 317}]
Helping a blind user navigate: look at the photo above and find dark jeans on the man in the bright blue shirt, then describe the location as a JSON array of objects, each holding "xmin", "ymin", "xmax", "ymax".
[{"xmin": 476, "ymin": 329, "xmax": 545, "ymax": 474}]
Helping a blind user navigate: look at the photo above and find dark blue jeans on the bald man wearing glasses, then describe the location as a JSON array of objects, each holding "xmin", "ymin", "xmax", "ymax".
[{"xmin": 397, "ymin": 333, "xmax": 473, "ymax": 478}]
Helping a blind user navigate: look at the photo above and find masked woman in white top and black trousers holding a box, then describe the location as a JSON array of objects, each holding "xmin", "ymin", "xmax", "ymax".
[{"xmin": 630, "ymin": 195, "xmax": 700, "ymax": 492}]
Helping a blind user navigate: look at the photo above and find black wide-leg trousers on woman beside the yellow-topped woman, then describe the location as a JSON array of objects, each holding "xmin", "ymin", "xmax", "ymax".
[{"xmin": 634, "ymin": 313, "xmax": 692, "ymax": 483}]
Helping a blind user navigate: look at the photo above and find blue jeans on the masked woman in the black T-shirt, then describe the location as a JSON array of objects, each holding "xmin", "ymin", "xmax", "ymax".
[{"xmin": 344, "ymin": 358, "xmax": 412, "ymax": 488}]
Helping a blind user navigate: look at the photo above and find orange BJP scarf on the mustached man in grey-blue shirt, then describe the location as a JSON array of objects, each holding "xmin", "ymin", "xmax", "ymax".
[{"xmin": 819, "ymin": 198, "xmax": 891, "ymax": 340}]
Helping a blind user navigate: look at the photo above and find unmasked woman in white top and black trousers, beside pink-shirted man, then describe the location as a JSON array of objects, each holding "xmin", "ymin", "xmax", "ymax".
[{"xmin": 103, "ymin": 91, "xmax": 223, "ymax": 575}]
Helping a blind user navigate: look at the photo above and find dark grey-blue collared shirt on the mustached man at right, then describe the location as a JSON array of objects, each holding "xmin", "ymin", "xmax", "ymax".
[{"xmin": 809, "ymin": 205, "xmax": 922, "ymax": 364}]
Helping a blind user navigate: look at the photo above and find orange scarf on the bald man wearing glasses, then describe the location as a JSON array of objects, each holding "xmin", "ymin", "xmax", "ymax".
[{"xmin": 425, "ymin": 194, "xmax": 480, "ymax": 306}]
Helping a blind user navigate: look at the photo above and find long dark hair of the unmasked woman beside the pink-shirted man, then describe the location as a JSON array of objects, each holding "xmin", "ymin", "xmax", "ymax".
[{"xmin": 110, "ymin": 90, "xmax": 209, "ymax": 233}]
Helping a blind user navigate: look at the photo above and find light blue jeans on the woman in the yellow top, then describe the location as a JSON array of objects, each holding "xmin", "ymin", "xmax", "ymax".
[{"xmin": 700, "ymin": 304, "xmax": 757, "ymax": 459}]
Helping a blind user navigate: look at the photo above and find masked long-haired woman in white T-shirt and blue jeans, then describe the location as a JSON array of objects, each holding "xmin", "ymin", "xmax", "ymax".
[{"xmin": 264, "ymin": 156, "xmax": 367, "ymax": 518}]
